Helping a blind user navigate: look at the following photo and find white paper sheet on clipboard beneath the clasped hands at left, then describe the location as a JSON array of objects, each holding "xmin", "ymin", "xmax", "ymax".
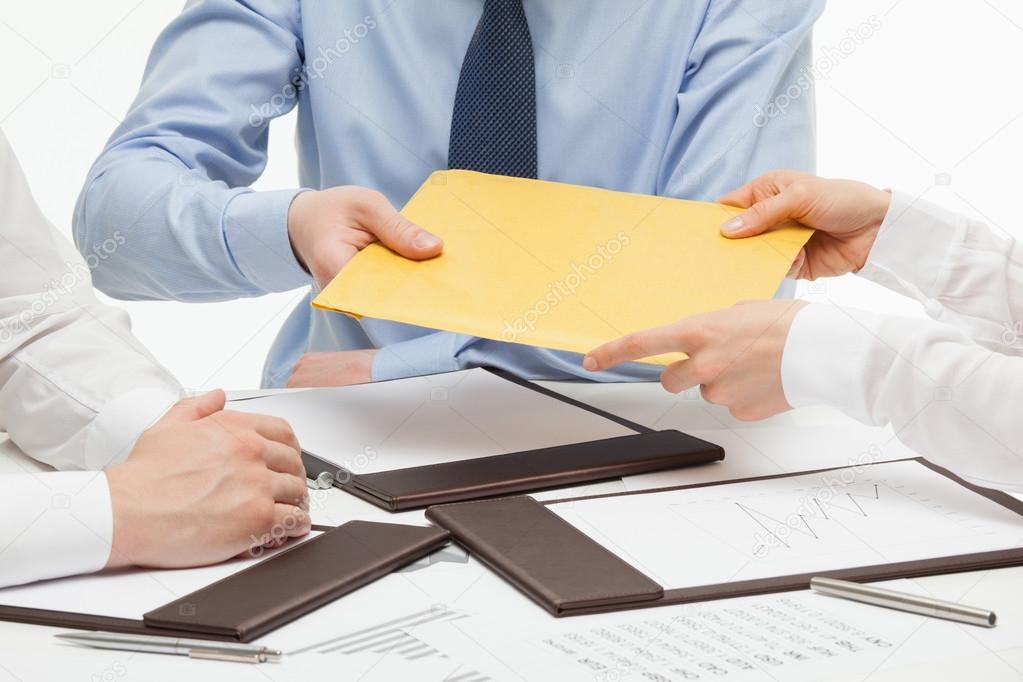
[{"xmin": 0, "ymin": 531, "xmax": 320, "ymax": 620}]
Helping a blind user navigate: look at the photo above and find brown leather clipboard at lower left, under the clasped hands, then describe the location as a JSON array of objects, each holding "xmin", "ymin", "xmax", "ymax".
[{"xmin": 0, "ymin": 520, "xmax": 449, "ymax": 642}]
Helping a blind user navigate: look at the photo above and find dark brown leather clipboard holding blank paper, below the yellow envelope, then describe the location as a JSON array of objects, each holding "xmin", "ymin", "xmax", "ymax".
[{"xmin": 302, "ymin": 369, "xmax": 724, "ymax": 511}]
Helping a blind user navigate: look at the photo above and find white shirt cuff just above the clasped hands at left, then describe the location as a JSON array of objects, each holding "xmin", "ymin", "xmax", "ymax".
[{"xmin": 84, "ymin": 389, "xmax": 180, "ymax": 469}]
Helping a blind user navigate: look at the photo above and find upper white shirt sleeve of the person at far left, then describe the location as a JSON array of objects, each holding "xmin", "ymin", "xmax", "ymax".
[{"xmin": 0, "ymin": 135, "xmax": 181, "ymax": 469}]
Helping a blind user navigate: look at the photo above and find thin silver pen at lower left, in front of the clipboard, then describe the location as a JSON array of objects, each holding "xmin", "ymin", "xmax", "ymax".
[{"xmin": 55, "ymin": 632, "xmax": 284, "ymax": 663}]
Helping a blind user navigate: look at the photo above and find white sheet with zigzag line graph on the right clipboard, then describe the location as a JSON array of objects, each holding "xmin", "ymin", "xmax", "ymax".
[{"xmin": 548, "ymin": 461, "xmax": 1023, "ymax": 587}]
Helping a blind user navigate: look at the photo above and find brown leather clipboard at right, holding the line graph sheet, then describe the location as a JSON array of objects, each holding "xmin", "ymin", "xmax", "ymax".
[{"xmin": 427, "ymin": 458, "xmax": 1023, "ymax": 617}]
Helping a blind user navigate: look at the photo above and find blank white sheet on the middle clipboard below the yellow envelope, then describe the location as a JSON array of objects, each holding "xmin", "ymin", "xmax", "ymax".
[{"xmin": 229, "ymin": 369, "xmax": 635, "ymax": 473}]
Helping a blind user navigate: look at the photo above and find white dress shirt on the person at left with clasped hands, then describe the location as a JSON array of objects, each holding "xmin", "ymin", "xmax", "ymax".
[{"xmin": 0, "ymin": 133, "xmax": 181, "ymax": 586}]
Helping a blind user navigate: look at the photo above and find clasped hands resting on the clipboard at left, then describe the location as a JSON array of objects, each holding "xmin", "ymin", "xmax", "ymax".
[{"xmin": 106, "ymin": 391, "xmax": 310, "ymax": 567}]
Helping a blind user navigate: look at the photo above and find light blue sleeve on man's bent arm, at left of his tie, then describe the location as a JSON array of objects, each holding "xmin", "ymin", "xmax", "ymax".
[{"xmin": 74, "ymin": 0, "xmax": 311, "ymax": 301}]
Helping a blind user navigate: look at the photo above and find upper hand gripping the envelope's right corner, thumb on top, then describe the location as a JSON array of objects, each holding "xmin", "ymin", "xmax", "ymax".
[{"xmin": 720, "ymin": 171, "xmax": 891, "ymax": 279}]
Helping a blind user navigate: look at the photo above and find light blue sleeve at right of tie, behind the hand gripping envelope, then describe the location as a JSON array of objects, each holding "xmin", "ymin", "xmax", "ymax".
[{"xmin": 658, "ymin": 0, "xmax": 825, "ymax": 201}]
